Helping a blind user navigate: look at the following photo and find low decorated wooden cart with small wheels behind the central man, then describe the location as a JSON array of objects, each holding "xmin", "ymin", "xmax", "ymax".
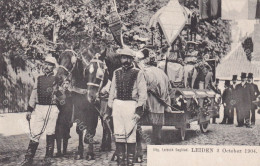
[{"xmin": 140, "ymin": 88, "xmax": 220, "ymax": 140}]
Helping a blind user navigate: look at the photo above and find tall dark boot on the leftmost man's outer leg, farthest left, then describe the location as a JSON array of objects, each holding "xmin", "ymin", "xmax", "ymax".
[{"xmin": 20, "ymin": 140, "xmax": 39, "ymax": 166}]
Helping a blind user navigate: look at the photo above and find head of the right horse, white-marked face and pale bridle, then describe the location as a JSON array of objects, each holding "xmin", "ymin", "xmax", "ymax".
[{"xmin": 86, "ymin": 57, "xmax": 106, "ymax": 103}]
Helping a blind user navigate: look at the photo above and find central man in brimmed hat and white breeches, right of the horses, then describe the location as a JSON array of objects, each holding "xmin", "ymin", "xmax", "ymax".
[{"xmin": 104, "ymin": 48, "xmax": 147, "ymax": 165}]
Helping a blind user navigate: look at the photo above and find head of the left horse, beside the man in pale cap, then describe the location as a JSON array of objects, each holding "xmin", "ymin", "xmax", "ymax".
[{"xmin": 56, "ymin": 51, "xmax": 77, "ymax": 85}]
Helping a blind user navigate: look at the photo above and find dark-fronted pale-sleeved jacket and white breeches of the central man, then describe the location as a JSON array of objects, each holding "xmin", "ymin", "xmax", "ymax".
[{"xmin": 108, "ymin": 66, "xmax": 147, "ymax": 143}]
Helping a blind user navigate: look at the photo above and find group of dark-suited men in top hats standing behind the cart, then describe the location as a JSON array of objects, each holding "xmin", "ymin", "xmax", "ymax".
[{"xmin": 220, "ymin": 73, "xmax": 260, "ymax": 128}]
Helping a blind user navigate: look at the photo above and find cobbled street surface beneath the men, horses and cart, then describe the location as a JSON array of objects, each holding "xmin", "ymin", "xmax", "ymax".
[{"xmin": 0, "ymin": 113, "xmax": 260, "ymax": 166}]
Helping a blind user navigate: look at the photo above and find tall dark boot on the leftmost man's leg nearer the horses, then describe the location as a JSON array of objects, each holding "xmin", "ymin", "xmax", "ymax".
[{"xmin": 43, "ymin": 135, "xmax": 55, "ymax": 166}]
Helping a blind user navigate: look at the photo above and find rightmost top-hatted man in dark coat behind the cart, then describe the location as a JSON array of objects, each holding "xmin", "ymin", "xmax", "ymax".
[{"xmin": 247, "ymin": 73, "xmax": 260, "ymax": 125}]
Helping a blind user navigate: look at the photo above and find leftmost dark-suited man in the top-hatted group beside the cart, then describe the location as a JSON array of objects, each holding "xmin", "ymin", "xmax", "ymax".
[{"xmin": 220, "ymin": 80, "xmax": 231, "ymax": 124}]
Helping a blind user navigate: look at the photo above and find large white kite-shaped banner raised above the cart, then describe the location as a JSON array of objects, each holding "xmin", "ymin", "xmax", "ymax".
[{"xmin": 158, "ymin": 0, "xmax": 188, "ymax": 45}]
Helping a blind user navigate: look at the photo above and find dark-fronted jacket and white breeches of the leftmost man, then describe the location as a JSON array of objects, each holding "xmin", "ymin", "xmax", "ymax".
[{"xmin": 29, "ymin": 73, "xmax": 59, "ymax": 142}]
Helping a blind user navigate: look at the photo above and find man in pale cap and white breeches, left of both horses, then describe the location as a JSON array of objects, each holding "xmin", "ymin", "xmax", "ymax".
[{"xmin": 21, "ymin": 56, "xmax": 59, "ymax": 166}]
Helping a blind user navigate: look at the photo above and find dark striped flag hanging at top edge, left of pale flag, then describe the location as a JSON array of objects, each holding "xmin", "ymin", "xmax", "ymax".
[{"xmin": 199, "ymin": 0, "xmax": 221, "ymax": 19}]
